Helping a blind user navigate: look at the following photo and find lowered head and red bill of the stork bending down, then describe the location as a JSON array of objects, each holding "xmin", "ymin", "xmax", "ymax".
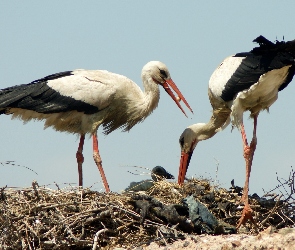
[{"xmin": 178, "ymin": 123, "xmax": 209, "ymax": 185}]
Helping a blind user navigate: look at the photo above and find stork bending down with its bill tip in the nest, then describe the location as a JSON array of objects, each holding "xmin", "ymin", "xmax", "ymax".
[{"xmin": 178, "ymin": 36, "xmax": 295, "ymax": 228}]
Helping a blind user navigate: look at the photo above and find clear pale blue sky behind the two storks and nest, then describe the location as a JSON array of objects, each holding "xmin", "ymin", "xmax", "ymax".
[{"xmin": 0, "ymin": 0, "xmax": 295, "ymax": 195}]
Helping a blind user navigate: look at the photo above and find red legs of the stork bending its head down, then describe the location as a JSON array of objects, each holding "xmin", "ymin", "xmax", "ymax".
[{"xmin": 237, "ymin": 114, "xmax": 258, "ymax": 228}]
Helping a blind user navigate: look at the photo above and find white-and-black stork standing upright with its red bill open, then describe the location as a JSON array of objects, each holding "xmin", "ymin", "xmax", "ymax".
[{"xmin": 0, "ymin": 61, "xmax": 192, "ymax": 192}]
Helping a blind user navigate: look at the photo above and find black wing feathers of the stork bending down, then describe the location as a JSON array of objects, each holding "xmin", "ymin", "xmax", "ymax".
[{"xmin": 221, "ymin": 36, "xmax": 295, "ymax": 101}]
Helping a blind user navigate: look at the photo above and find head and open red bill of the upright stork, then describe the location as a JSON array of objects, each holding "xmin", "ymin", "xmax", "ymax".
[{"xmin": 141, "ymin": 61, "xmax": 193, "ymax": 116}]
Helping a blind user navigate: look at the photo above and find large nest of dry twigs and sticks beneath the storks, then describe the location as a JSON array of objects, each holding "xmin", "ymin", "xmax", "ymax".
[{"xmin": 0, "ymin": 172, "xmax": 295, "ymax": 249}]
